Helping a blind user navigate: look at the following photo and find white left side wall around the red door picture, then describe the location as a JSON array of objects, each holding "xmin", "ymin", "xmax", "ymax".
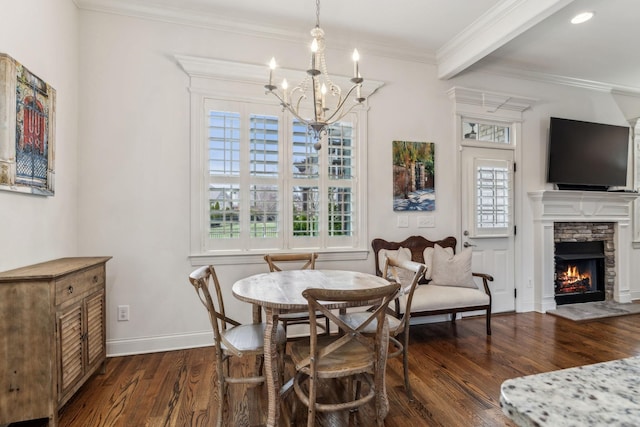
[{"xmin": 0, "ymin": 0, "xmax": 78, "ymax": 271}]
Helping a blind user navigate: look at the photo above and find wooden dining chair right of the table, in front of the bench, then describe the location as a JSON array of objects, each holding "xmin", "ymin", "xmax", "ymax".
[{"xmin": 340, "ymin": 257, "xmax": 428, "ymax": 400}]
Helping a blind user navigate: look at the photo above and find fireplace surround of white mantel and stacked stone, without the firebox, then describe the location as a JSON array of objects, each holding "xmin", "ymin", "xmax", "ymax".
[{"xmin": 529, "ymin": 191, "xmax": 637, "ymax": 313}]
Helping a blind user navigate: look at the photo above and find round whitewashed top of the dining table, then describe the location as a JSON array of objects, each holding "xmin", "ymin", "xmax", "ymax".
[{"xmin": 232, "ymin": 270, "xmax": 389, "ymax": 310}]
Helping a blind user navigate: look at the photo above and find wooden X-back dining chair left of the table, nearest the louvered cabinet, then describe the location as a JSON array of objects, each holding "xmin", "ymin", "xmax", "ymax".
[{"xmin": 189, "ymin": 266, "xmax": 286, "ymax": 427}]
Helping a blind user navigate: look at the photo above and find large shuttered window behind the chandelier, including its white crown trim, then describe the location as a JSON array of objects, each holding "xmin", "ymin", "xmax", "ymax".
[{"xmin": 175, "ymin": 55, "xmax": 384, "ymax": 265}]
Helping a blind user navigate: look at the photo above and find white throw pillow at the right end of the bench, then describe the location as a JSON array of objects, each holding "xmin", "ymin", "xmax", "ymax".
[{"xmin": 431, "ymin": 245, "xmax": 478, "ymax": 289}]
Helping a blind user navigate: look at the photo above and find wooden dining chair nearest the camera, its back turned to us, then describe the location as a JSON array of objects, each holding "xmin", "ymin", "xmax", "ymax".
[{"xmin": 291, "ymin": 283, "xmax": 400, "ymax": 427}]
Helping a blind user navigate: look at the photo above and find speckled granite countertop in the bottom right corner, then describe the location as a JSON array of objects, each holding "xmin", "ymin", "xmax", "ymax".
[{"xmin": 500, "ymin": 357, "xmax": 640, "ymax": 427}]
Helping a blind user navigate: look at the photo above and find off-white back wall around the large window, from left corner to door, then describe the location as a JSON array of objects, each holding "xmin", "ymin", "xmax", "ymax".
[{"xmin": 79, "ymin": 12, "xmax": 476, "ymax": 353}]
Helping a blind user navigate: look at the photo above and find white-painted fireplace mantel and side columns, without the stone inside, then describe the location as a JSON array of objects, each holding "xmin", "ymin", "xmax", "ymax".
[{"xmin": 528, "ymin": 190, "xmax": 638, "ymax": 313}]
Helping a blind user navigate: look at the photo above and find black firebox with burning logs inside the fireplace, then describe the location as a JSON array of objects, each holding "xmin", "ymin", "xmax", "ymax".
[{"xmin": 555, "ymin": 241, "xmax": 605, "ymax": 305}]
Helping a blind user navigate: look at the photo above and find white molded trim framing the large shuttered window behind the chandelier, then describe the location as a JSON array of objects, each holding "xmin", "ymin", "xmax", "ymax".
[{"xmin": 175, "ymin": 55, "xmax": 383, "ymax": 266}]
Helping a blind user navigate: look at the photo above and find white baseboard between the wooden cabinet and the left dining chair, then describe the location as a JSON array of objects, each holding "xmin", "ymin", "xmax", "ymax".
[{"xmin": 107, "ymin": 332, "xmax": 213, "ymax": 357}]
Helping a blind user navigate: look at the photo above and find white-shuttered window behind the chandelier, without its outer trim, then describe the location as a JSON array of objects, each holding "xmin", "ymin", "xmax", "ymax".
[{"xmin": 198, "ymin": 99, "xmax": 364, "ymax": 255}]
